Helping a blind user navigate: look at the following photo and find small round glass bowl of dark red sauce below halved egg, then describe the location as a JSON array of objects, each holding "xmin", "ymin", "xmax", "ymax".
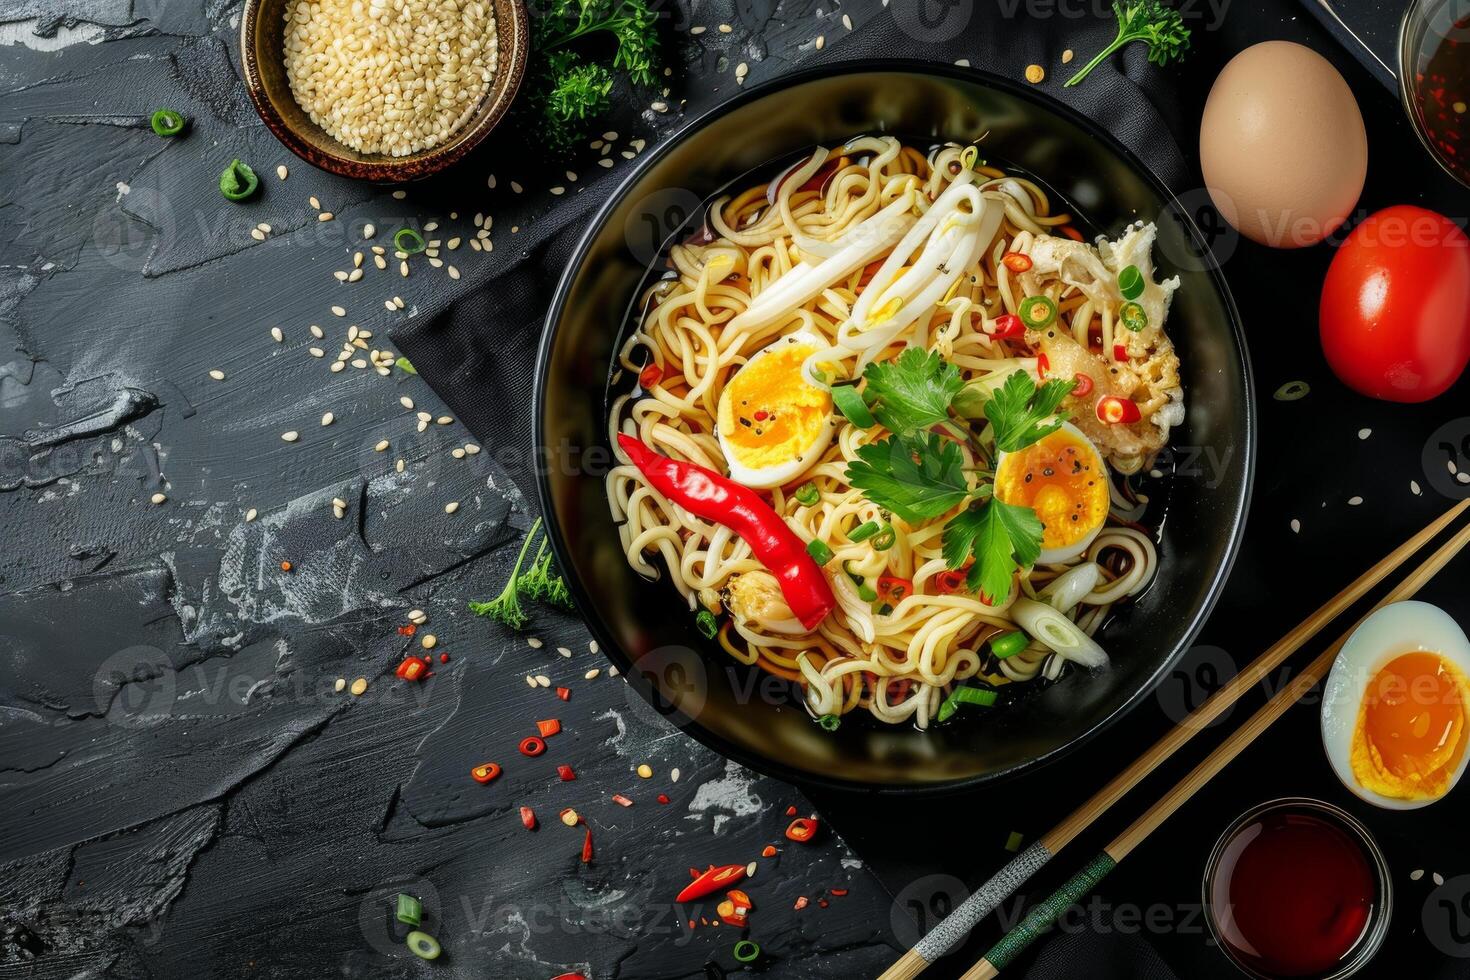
[{"xmin": 1204, "ymin": 798, "xmax": 1392, "ymax": 980}]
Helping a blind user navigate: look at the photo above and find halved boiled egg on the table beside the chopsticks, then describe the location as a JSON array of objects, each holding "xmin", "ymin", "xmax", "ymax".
[{"xmin": 1322, "ymin": 602, "xmax": 1470, "ymax": 810}]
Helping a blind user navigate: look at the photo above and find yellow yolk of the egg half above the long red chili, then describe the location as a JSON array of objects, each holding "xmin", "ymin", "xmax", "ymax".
[{"xmin": 719, "ymin": 344, "xmax": 832, "ymax": 469}]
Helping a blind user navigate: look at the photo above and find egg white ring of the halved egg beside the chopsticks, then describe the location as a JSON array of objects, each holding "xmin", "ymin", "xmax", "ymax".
[{"xmin": 1322, "ymin": 601, "xmax": 1470, "ymax": 810}]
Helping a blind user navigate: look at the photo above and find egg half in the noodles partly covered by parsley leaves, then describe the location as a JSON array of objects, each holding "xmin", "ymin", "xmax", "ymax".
[{"xmin": 995, "ymin": 422, "xmax": 1110, "ymax": 564}]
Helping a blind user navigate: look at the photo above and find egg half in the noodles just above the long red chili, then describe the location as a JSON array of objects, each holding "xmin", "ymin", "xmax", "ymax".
[{"xmin": 716, "ymin": 332, "xmax": 832, "ymax": 488}]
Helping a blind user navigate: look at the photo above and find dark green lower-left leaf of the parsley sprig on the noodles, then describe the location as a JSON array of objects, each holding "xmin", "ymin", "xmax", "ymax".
[{"xmin": 847, "ymin": 432, "xmax": 972, "ymax": 522}]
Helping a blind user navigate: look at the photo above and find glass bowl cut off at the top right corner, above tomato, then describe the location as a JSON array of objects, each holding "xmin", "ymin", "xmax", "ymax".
[{"xmin": 1398, "ymin": 0, "xmax": 1470, "ymax": 187}]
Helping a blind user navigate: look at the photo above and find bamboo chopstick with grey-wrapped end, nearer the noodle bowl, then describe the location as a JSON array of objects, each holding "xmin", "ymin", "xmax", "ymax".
[{"xmin": 879, "ymin": 500, "xmax": 1470, "ymax": 980}]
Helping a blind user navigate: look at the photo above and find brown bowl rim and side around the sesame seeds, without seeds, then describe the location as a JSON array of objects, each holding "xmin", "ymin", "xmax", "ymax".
[{"xmin": 240, "ymin": 0, "xmax": 531, "ymax": 182}]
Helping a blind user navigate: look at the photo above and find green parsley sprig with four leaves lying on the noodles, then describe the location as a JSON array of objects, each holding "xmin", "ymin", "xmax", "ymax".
[{"xmin": 847, "ymin": 348, "xmax": 1076, "ymax": 602}]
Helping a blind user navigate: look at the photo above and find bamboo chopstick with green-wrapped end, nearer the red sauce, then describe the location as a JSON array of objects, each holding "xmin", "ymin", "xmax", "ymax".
[{"xmin": 961, "ymin": 508, "xmax": 1470, "ymax": 980}]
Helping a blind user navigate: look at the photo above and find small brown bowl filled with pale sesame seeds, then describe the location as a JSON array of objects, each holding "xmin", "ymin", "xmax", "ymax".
[{"xmin": 240, "ymin": 0, "xmax": 531, "ymax": 182}]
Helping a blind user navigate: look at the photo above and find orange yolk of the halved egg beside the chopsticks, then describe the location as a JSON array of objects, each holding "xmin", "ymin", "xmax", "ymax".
[{"xmin": 1351, "ymin": 652, "xmax": 1466, "ymax": 799}]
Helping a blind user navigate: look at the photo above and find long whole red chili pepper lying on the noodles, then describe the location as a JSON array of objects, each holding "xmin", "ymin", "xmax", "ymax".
[{"xmin": 617, "ymin": 435, "xmax": 836, "ymax": 630}]
